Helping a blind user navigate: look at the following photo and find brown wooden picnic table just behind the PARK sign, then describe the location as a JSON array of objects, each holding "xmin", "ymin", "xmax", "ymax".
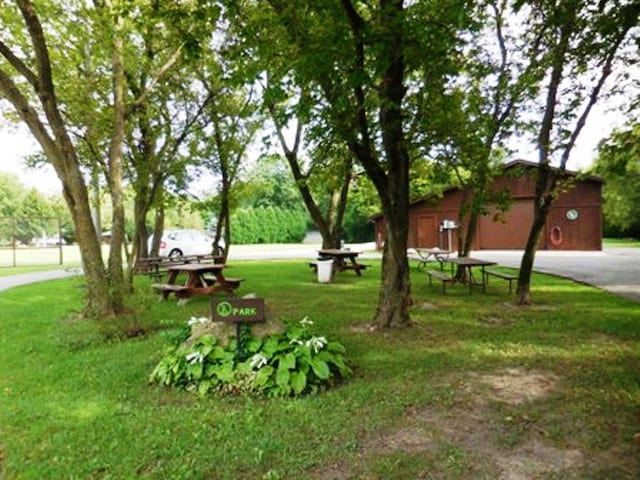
[{"xmin": 152, "ymin": 263, "xmax": 242, "ymax": 300}]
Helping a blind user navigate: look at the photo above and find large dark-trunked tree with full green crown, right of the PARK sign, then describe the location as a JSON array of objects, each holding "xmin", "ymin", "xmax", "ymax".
[{"xmin": 233, "ymin": 0, "xmax": 466, "ymax": 328}]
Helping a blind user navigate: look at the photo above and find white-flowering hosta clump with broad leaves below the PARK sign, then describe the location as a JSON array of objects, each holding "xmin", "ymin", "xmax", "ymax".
[{"xmin": 150, "ymin": 317, "xmax": 352, "ymax": 397}]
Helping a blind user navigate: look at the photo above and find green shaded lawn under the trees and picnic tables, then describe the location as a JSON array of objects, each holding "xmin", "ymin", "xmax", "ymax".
[{"xmin": 0, "ymin": 261, "xmax": 640, "ymax": 479}]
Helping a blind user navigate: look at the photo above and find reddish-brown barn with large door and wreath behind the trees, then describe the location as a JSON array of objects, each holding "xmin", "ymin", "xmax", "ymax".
[{"xmin": 374, "ymin": 160, "xmax": 602, "ymax": 250}]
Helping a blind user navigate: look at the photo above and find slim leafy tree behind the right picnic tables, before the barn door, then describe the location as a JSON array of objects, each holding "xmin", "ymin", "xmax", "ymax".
[{"xmin": 427, "ymin": 0, "xmax": 540, "ymax": 266}]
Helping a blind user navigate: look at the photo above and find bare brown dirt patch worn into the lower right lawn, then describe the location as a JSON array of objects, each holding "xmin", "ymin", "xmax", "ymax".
[{"xmin": 342, "ymin": 368, "xmax": 586, "ymax": 480}]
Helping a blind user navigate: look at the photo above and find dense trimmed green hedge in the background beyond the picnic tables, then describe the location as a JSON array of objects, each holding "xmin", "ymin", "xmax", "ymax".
[{"xmin": 231, "ymin": 207, "xmax": 307, "ymax": 245}]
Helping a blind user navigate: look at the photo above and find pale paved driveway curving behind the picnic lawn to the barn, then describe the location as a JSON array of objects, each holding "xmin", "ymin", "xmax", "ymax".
[{"xmin": 0, "ymin": 244, "xmax": 640, "ymax": 302}]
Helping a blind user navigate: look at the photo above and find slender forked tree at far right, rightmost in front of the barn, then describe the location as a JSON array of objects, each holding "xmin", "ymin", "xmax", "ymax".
[{"xmin": 517, "ymin": 0, "xmax": 640, "ymax": 305}]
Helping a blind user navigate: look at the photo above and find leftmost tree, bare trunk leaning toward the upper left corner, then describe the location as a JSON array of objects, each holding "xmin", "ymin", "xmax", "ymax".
[{"xmin": 0, "ymin": 0, "xmax": 122, "ymax": 317}]
